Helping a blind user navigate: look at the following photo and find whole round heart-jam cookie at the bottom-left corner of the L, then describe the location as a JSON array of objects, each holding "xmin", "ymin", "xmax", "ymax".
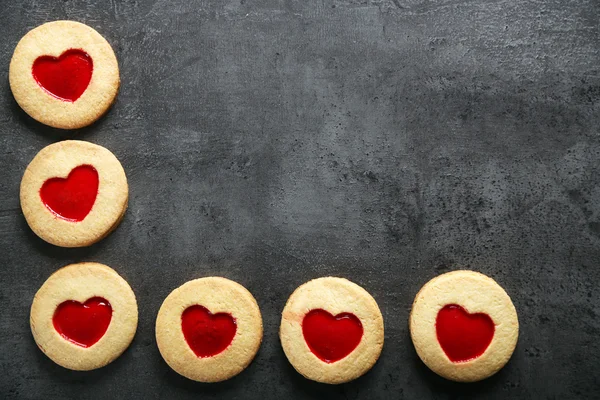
[{"xmin": 30, "ymin": 262, "xmax": 138, "ymax": 371}]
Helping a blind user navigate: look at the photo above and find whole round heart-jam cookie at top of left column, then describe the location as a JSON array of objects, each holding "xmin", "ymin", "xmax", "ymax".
[{"xmin": 8, "ymin": 21, "xmax": 120, "ymax": 129}]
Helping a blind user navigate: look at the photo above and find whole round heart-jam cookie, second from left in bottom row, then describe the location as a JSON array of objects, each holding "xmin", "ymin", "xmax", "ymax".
[{"xmin": 156, "ymin": 277, "xmax": 263, "ymax": 382}]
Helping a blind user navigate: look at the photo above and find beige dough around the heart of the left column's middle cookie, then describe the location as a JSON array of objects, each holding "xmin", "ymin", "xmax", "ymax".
[{"xmin": 21, "ymin": 140, "xmax": 129, "ymax": 247}]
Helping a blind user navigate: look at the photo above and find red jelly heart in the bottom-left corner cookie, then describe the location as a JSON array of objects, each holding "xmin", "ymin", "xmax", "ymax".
[{"xmin": 52, "ymin": 297, "xmax": 112, "ymax": 347}]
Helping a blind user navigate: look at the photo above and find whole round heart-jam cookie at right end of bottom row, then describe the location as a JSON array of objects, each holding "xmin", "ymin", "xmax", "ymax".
[{"xmin": 409, "ymin": 271, "xmax": 519, "ymax": 382}]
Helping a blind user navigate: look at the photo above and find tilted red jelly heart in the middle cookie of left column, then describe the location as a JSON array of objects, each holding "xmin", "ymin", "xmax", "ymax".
[{"xmin": 40, "ymin": 165, "xmax": 100, "ymax": 222}]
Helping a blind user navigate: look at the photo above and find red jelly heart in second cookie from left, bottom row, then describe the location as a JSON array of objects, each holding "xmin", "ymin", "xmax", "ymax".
[{"xmin": 181, "ymin": 305, "xmax": 237, "ymax": 357}]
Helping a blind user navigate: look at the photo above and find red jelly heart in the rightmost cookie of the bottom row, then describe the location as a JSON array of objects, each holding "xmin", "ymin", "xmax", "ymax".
[{"xmin": 435, "ymin": 304, "xmax": 495, "ymax": 362}]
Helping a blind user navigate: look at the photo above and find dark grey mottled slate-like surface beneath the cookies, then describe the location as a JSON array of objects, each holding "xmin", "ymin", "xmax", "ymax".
[{"xmin": 0, "ymin": 0, "xmax": 600, "ymax": 399}]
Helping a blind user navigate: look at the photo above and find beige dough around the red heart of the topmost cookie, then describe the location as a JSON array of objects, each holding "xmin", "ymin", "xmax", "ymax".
[{"xmin": 9, "ymin": 21, "xmax": 120, "ymax": 129}]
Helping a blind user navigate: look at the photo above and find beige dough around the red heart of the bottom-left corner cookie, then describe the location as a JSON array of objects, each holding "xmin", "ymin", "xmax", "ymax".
[{"xmin": 30, "ymin": 262, "xmax": 138, "ymax": 371}]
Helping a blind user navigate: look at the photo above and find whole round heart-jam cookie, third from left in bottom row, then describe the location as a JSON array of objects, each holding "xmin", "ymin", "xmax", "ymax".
[{"xmin": 279, "ymin": 277, "xmax": 384, "ymax": 384}]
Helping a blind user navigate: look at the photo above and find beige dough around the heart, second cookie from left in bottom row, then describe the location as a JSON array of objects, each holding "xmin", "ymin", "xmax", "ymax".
[{"xmin": 156, "ymin": 277, "xmax": 263, "ymax": 383}]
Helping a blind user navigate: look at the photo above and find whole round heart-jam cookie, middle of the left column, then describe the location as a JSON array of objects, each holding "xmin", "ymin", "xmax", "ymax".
[{"xmin": 21, "ymin": 140, "xmax": 129, "ymax": 247}]
